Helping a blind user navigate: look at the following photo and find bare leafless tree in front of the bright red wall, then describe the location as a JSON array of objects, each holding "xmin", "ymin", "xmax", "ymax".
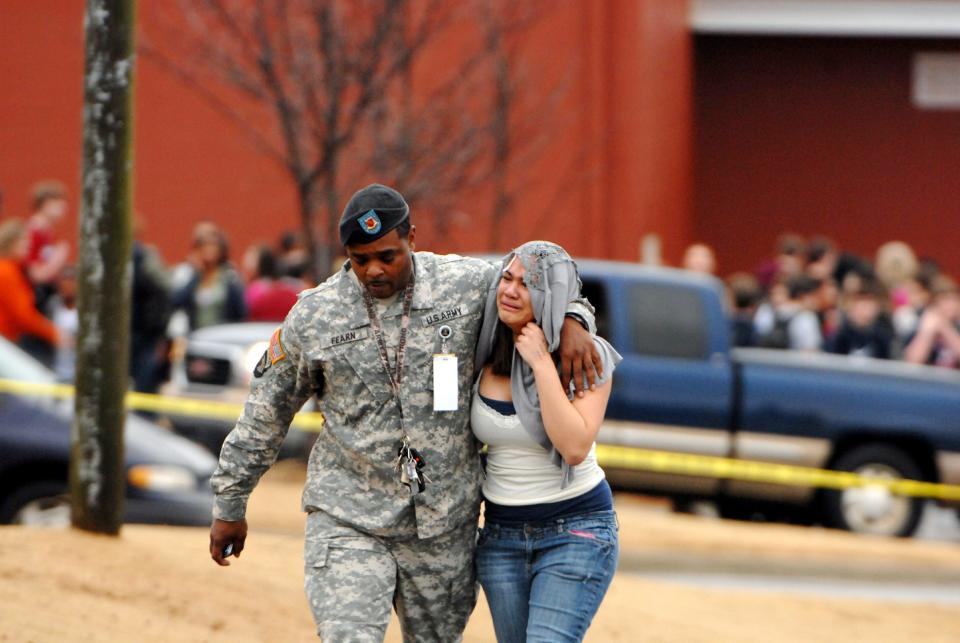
[{"xmin": 146, "ymin": 0, "xmax": 568, "ymax": 271}]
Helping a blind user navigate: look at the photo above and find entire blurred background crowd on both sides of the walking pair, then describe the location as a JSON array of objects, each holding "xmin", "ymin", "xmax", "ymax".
[{"xmin": 0, "ymin": 181, "xmax": 960, "ymax": 406}]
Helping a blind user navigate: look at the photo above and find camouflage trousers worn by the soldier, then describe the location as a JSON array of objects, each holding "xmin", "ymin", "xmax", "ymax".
[{"xmin": 304, "ymin": 511, "xmax": 477, "ymax": 643}]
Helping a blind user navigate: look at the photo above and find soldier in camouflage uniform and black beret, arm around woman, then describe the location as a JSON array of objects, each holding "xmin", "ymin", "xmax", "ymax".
[{"xmin": 210, "ymin": 184, "xmax": 600, "ymax": 642}]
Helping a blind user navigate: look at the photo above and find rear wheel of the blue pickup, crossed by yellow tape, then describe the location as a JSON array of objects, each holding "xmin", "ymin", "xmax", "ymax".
[{"xmin": 823, "ymin": 444, "xmax": 924, "ymax": 537}]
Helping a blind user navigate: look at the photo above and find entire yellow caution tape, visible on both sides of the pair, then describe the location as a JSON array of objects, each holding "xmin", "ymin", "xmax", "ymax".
[{"xmin": 0, "ymin": 379, "xmax": 960, "ymax": 500}]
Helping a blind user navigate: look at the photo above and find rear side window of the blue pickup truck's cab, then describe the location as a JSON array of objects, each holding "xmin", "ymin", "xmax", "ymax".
[{"xmin": 629, "ymin": 283, "xmax": 707, "ymax": 359}]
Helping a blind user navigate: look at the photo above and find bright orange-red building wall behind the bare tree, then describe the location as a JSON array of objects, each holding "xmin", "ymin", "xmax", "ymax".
[{"xmin": 0, "ymin": 0, "xmax": 692, "ymax": 272}]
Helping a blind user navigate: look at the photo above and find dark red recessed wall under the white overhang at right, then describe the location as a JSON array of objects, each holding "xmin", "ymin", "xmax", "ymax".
[{"xmin": 694, "ymin": 37, "xmax": 960, "ymax": 274}]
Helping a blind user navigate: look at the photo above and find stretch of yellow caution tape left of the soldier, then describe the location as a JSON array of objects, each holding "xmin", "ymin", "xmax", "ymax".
[{"xmin": 0, "ymin": 379, "xmax": 323, "ymax": 431}]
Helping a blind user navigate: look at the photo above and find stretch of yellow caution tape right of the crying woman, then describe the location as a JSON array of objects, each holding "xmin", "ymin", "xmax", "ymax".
[{"xmin": 597, "ymin": 444, "xmax": 960, "ymax": 500}]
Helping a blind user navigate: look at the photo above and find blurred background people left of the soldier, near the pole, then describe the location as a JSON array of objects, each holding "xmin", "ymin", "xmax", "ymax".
[{"xmin": 0, "ymin": 181, "xmax": 316, "ymax": 393}]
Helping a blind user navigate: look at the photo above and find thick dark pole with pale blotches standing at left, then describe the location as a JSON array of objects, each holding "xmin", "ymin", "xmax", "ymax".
[{"xmin": 70, "ymin": 0, "xmax": 135, "ymax": 534}]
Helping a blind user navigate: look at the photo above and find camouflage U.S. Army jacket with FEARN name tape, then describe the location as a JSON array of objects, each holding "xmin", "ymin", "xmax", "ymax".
[{"xmin": 211, "ymin": 252, "xmax": 593, "ymax": 538}]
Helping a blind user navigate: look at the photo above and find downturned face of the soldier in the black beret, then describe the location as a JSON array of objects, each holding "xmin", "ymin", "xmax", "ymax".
[{"xmin": 347, "ymin": 226, "xmax": 416, "ymax": 299}]
